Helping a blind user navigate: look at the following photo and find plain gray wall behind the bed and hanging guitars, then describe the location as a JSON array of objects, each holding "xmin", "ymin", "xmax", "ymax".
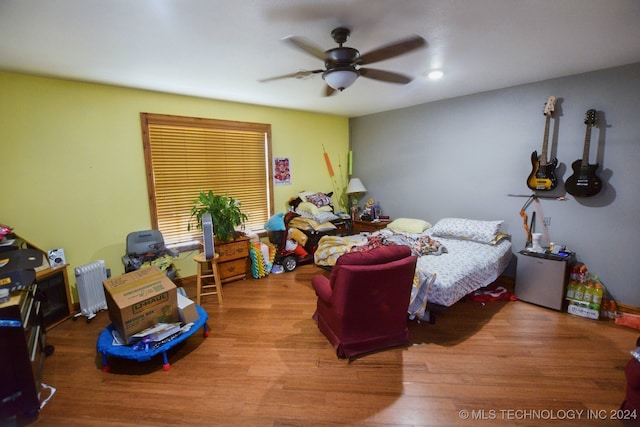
[{"xmin": 350, "ymin": 63, "xmax": 640, "ymax": 307}]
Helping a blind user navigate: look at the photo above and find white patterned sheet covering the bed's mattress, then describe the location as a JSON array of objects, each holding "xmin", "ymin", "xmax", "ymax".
[{"xmin": 416, "ymin": 237, "xmax": 513, "ymax": 307}]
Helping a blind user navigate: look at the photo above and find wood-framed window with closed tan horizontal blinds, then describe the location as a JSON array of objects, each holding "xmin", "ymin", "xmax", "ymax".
[{"xmin": 140, "ymin": 113, "xmax": 273, "ymax": 248}]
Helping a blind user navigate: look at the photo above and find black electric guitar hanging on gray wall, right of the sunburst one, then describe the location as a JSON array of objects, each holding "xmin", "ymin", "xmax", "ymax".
[{"xmin": 564, "ymin": 109, "xmax": 602, "ymax": 197}]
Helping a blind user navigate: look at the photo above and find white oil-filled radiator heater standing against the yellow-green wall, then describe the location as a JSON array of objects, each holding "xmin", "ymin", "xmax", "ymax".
[{"xmin": 74, "ymin": 260, "xmax": 107, "ymax": 322}]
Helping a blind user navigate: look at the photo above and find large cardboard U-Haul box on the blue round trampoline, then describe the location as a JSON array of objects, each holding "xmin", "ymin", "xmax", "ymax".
[{"xmin": 102, "ymin": 266, "xmax": 179, "ymax": 343}]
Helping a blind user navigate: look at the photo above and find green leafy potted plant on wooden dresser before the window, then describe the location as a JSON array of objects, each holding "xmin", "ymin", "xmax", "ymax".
[{"xmin": 188, "ymin": 190, "xmax": 248, "ymax": 242}]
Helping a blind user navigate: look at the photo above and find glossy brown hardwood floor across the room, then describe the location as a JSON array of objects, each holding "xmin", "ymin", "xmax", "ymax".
[{"xmin": 22, "ymin": 265, "xmax": 639, "ymax": 426}]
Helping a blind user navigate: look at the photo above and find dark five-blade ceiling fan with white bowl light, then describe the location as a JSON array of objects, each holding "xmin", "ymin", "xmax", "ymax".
[{"xmin": 260, "ymin": 27, "xmax": 427, "ymax": 96}]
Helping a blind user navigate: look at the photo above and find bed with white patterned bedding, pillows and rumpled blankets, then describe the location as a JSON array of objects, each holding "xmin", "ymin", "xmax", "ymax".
[{"xmin": 315, "ymin": 218, "xmax": 513, "ymax": 320}]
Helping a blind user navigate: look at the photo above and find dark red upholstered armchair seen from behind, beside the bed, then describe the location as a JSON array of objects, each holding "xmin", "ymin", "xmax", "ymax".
[{"xmin": 311, "ymin": 245, "xmax": 417, "ymax": 358}]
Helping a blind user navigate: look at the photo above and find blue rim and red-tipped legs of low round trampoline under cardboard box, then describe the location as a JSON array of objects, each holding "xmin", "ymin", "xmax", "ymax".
[{"xmin": 96, "ymin": 305, "xmax": 209, "ymax": 372}]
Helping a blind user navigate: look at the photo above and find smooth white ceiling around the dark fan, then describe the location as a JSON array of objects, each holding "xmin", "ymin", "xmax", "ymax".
[{"xmin": 0, "ymin": 0, "xmax": 640, "ymax": 117}]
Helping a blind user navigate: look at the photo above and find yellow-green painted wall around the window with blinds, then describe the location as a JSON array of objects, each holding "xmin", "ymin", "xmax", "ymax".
[{"xmin": 0, "ymin": 72, "xmax": 349, "ymax": 301}]
